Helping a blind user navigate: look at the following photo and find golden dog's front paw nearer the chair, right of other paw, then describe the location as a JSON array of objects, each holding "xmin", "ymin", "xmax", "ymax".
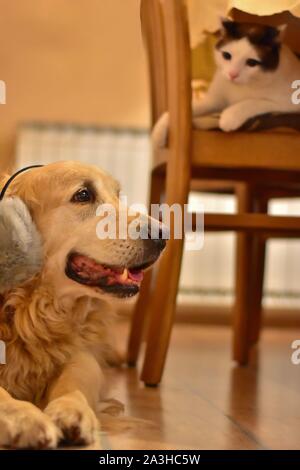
[{"xmin": 45, "ymin": 392, "xmax": 100, "ymax": 445}]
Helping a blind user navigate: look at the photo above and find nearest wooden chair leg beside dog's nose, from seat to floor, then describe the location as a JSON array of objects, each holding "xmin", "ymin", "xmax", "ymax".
[{"xmin": 141, "ymin": 154, "xmax": 190, "ymax": 386}]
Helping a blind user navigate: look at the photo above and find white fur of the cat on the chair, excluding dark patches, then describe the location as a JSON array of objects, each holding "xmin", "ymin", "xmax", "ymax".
[{"xmin": 153, "ymin": 26, "xmax": 300, "ymax": 146}]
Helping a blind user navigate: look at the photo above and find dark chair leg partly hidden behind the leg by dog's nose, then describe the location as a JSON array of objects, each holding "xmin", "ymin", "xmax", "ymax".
[{"xmin": 127, "ymin": 174, "xmax": 165, "ymax": 367}]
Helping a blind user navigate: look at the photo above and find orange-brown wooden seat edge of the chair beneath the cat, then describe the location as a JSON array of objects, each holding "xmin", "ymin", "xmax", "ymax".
[{"xmin": 153, "ymin": 130, "xmax": 300, "ymax": 184}]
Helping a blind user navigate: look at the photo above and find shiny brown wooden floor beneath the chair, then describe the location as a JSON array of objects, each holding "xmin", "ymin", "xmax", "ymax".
[{"xmin": 98, "ymin": 324, "xmax": 300, "ymax": 449}]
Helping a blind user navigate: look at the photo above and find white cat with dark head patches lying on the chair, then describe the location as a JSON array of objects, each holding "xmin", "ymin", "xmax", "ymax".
[{"xmin": 153, "ymin": 19, "xmax": 300, "ymax": 145}]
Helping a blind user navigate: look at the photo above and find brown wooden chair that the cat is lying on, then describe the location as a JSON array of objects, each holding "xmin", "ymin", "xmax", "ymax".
[{"xmin": 128, "ymin": 0, "xmax": 300, "ymax": 385}]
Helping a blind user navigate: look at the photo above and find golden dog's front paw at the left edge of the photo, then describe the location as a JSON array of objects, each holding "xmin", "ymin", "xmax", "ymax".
[{"xmin": 0, "ymin": 400, "xmax": 60, "ymax": 449}]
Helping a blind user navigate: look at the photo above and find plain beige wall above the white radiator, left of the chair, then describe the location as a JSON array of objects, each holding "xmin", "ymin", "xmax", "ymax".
[{"xmin": 0, "ymin": 0, "xmax": 149, "ymax": 166}]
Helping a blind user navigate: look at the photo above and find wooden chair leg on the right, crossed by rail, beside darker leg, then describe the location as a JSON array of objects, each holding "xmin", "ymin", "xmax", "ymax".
[{"xmin": 233, "ymin": 184, "xmax": 253, "ymax": 365}]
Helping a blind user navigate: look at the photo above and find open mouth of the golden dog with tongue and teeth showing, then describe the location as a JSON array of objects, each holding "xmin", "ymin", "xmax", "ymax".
[{"xmin": 66, "ymin": 253, "xmax": 143, "ymax": 297}]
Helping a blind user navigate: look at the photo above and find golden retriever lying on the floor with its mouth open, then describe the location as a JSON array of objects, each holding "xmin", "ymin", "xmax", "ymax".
[{"xmin": 0, "ymin": 162, "xmax": 165, "ymax": 448}]
